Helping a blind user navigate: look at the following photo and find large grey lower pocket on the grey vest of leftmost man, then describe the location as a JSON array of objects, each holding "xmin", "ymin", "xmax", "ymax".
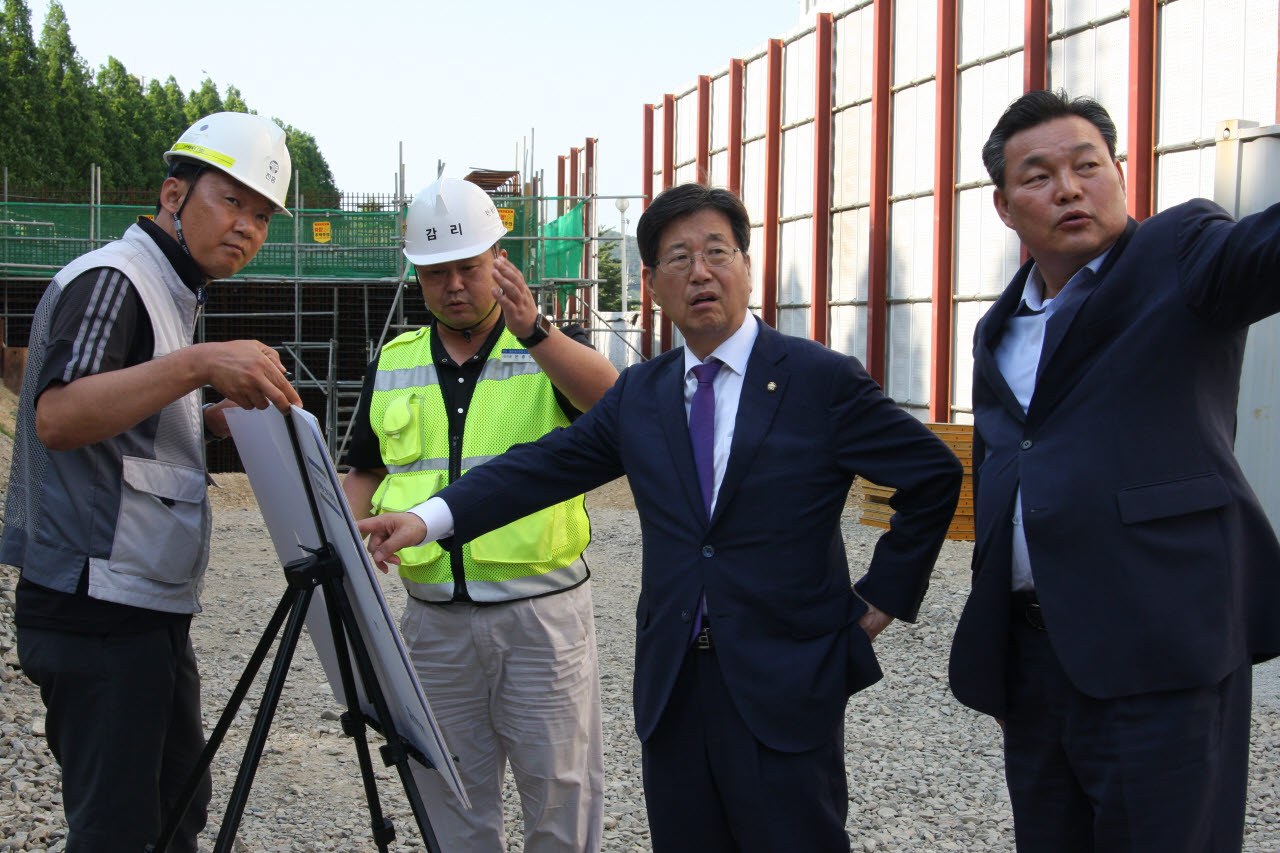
[{"xmin": 108, "ymin": 456, "xmax": 206, "ymax": 584}]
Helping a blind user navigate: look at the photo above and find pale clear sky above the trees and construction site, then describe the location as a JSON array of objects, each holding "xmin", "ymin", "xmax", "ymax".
[{"xmin": 27, "ymin": 0, "xmax": 800, "ymax": 222}]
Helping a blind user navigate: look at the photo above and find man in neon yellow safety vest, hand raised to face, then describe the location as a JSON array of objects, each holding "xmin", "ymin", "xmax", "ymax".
[{"xmin": 343, "ymin": 179, "xmax": 617, "ymax": 853}]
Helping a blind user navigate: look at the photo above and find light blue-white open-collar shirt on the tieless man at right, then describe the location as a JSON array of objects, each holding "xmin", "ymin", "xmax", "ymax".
[{"xmin": 996, "ymin": 250, "xmax": 1110, "ymax": 589}]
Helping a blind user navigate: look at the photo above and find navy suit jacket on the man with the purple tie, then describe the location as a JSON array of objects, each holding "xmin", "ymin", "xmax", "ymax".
[{"xmin": 439, "ymin": 316, "xmax": 961, "ymax": 752}]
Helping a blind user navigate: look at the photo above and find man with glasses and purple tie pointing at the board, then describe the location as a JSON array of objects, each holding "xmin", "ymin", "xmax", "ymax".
[{"xmin": 360, "ymin": 184, "xmax": 961, "ymax": 853}]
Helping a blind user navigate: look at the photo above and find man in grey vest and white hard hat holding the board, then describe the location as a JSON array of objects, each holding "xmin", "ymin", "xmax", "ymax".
[{"xmin": 0, "ymin": 113, "xmax": 301, "ymax": 853}]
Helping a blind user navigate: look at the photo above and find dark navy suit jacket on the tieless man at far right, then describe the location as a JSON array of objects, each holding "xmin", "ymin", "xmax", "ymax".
[{"xmin": 951, "ymin": 200, "xmax": 1280, "ymax": 716}]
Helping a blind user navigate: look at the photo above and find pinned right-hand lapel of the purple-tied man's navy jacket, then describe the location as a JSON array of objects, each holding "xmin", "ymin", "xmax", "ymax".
[{"xmin": 712, "ymin": 323, "xmax": 791, "ymax": 524}]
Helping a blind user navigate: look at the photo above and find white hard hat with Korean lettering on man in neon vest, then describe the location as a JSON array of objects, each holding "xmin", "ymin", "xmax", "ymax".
[{"xmin": 404, "ymin": 178, "xmax": 507, "ymax": 265}]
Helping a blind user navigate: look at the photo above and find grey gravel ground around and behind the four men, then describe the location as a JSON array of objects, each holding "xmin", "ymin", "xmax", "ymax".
[{"xmin": 0, "ymin": 414, "xmax": 1280, "ymax": 853}]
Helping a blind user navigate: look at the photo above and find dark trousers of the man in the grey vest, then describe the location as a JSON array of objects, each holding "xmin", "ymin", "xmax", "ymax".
[{"xmin": 18, "ymin": 622, "xmax": 211, "ymax": 853}]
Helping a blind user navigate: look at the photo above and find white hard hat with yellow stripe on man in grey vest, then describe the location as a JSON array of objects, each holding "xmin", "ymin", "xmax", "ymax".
[{"xmin": 164, "ymin": 113, "xmax": 293, "ymax": 216}]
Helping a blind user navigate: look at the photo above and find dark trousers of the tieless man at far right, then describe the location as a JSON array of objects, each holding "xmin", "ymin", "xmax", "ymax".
[{"xmin": 1005, "ymin": 616, "xmax": 1252, "ymax": 853}]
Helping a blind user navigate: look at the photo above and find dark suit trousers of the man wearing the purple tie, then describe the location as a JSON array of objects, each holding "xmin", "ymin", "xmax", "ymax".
[{"xmin": 643, "ymin": 640, "xmax": 849, "ymax": 853}]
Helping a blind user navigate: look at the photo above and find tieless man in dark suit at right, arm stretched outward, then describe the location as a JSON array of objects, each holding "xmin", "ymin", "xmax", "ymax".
[{"xmin": 951, "ymin": 92, "xmax": 1280, "ymax": 853}]
